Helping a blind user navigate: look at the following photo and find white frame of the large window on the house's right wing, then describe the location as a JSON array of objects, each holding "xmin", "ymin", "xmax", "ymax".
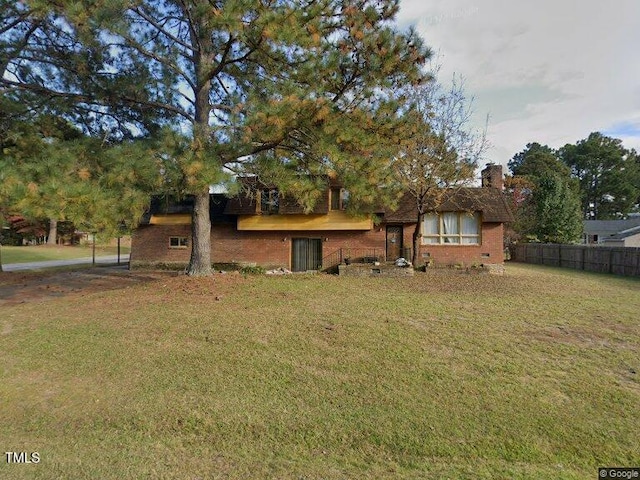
[{"xmin": 420, "ymin": 212, "xmax": 482, "ymax": 247}]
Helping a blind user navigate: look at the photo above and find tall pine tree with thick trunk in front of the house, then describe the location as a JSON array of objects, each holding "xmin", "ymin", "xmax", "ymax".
[{"xmin": 0, "ymin": 0, "xmax": 428, "ymax": 275}]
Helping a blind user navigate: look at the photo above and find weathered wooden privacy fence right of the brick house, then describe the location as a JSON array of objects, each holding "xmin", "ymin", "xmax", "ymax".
[{"xmin": 510, "ymin": 243, "xmax": 640, "ymax": 277}]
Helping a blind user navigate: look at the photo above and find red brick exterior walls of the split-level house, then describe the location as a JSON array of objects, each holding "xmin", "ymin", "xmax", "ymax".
[{"xmin": 131, "ymin": 219, "xmax": 503, "ymax": 268}]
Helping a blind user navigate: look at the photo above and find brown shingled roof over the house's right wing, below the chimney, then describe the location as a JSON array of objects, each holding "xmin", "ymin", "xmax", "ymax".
[{"xmin": 384, "ymin": 187, "xmax": 514, "ymax": 223}]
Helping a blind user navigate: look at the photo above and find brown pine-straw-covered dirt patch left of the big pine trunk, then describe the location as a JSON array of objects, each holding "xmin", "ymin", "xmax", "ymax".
[{"xmin": 0, "ymin": 266, "xmax": 178, "ymax": 307}]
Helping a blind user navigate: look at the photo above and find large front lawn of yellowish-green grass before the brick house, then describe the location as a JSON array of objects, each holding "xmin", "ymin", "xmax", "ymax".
[{"xmin": 0, "ymin": 265, "xmax": 640, "ymax": 480}]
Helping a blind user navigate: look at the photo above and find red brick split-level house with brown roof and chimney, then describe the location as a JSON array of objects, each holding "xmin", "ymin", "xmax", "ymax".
[{"xmin": 130, "ymin": 165, "xmax": 513, "ymax": 271}]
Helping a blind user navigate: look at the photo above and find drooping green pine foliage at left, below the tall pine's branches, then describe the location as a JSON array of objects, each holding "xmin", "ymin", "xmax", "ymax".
[{"xmin": 0, "ymin": 115, "xmax": 161, "ymax": 244}]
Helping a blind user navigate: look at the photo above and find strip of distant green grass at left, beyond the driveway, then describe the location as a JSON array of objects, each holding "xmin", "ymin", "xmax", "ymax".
[{"xmin": 2, "ymin": 245, "xmax": 131, "ymax": 264}]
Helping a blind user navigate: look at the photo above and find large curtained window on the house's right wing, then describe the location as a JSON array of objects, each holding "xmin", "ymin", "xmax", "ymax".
[{"xmin": 422, "ymin": 212, "xmax": 480, "ymax": 245}]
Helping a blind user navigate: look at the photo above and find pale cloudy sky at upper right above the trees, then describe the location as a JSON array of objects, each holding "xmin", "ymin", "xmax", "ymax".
[{"xmin": 398, "ymin": 0, "xmax": 640, "ymax": 172}]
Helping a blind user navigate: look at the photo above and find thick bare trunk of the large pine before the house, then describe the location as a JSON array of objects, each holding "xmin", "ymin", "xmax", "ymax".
[{"xmin": 187, "ymin": 189, "xmax": 212, "ymax": 277}]
